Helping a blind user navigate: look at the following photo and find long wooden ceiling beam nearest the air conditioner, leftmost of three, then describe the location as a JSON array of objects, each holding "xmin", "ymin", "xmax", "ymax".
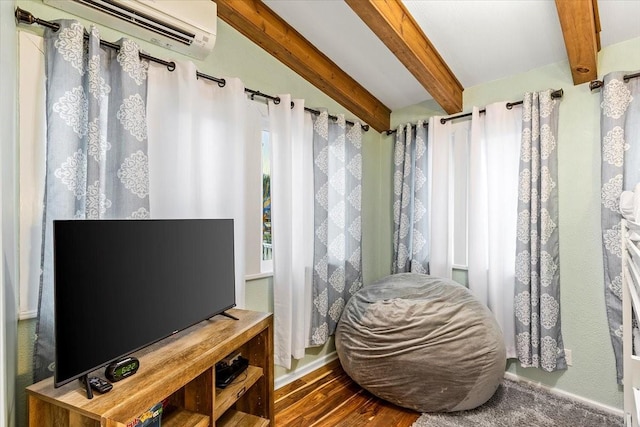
[{"xmin": 215, "ymin": 0, "xmax": 391, "ymax": 132}]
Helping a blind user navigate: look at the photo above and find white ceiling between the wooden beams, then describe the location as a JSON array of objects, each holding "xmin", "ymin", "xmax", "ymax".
[{"xmin": 263, "ymin": 0, "xmax": 640, "ymax": 110}]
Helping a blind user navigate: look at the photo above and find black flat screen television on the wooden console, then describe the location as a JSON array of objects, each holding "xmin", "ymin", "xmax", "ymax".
[{"xmin": 53, "ymin": 219, "xmax": 235, "ymax": 387}]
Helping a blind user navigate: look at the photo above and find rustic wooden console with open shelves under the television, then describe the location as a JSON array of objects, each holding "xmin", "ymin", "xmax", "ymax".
[{"xmin": 27, "ymin": 309, "xmax": 273, "ymax": 427}]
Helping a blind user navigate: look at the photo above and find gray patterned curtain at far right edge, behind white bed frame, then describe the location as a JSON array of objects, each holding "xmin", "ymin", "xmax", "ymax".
[{"xmin": 600, "ymin": 72, "xmax": 640, "ymax": 384}]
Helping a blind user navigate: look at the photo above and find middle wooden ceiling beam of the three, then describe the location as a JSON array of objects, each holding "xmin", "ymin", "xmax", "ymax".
[{"xmin": 345, "ymin": 0, "xmax": 464, "ymax": 114}]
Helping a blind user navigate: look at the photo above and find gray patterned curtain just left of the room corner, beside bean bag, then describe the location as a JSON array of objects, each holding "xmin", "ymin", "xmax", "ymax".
[{"xmin": 309, "ymin": 111, "xmax": 362, "ymax": 345}]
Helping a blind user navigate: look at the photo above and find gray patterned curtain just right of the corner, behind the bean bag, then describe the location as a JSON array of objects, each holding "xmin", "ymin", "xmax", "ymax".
[{"xmin": 392, "ymin": 121, "xmax": 429, "ymax": 274}]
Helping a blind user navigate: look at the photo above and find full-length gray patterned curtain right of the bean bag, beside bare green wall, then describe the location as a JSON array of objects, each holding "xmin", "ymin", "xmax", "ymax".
[{"xmin": 514, "ymin": 90, "xmax": 567, "ymax": 372}]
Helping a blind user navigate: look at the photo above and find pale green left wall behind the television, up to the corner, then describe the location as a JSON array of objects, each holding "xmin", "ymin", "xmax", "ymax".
[{"xmin": 16, "ymin": 0, "xmax": 391, "ymax": 425}]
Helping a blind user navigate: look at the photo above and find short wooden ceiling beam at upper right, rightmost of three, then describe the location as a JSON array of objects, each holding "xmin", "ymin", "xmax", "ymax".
[{"xmin": 556, "ymin": 0, "xmax": 600, "ymax": 85}]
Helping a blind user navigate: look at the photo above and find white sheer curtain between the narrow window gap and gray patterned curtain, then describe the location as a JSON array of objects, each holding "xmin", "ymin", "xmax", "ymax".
[{"xmin": 269, "ymin": 95, "xmax": 314, "ymax": 369}]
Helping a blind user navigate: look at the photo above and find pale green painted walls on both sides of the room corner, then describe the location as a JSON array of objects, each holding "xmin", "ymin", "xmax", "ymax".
[{"xmin": 12, "ymin": 0, "xmax": 640, "ymax": 425}]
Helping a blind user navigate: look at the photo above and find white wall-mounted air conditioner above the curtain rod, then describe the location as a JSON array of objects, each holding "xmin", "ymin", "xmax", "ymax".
[{"xmin": 43, "ymin": 0, "xmax": 217, "ymax": 59}]
